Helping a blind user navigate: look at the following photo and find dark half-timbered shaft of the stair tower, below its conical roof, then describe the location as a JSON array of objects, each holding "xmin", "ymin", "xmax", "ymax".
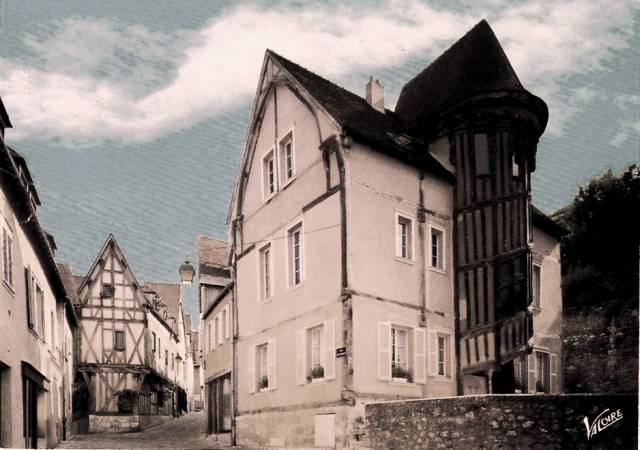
[{"xmin": 450, "ymin": 123, "xmax": 535, "ymax": 373}]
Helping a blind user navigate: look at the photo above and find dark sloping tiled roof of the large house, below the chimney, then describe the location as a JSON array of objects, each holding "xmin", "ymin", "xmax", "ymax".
[{"xmin": 267, "ymin": 50, "xmax": 452, "ymax": 179}]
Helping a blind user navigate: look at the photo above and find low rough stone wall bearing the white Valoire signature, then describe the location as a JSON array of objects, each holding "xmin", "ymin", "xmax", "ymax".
[{"xmin": 363, "ymin": 394, "xmax": 638, "ymax": 450}]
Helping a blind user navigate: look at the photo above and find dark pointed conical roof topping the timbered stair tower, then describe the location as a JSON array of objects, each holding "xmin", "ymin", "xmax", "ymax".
[{"xmin": 396, "ymin": 20, "xmax": 546, "ymax": 133}]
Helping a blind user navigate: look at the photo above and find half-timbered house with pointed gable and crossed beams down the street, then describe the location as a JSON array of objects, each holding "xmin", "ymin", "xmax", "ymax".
[{"xmin": 71, "ymin": 235, "xmax": 188, "ymax": 432}]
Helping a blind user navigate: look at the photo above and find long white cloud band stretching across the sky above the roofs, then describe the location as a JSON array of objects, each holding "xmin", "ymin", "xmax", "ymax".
[{"xmin": 0, "ymin": 0, "xmax": 632, "ymax": 146}]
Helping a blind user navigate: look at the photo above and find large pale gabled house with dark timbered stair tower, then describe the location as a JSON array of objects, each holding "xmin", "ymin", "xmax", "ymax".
[{"xmin": 226, "ymin": 21, "xmax": 562, "ymax": 447}]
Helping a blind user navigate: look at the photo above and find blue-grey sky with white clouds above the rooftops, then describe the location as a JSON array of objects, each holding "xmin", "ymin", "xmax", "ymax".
[{"xmin": 0, "ymin": 0, "xmax": 640, "ymax": 324}]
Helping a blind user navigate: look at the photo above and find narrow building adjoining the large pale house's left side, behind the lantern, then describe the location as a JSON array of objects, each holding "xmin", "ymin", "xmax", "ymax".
[{"xmin": 198, "ymin": 236, "xmax": 234, "ymax": 435}]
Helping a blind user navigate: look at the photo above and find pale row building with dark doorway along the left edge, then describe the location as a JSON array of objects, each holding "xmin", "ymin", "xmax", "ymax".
[{"xmin": 0, "ymin": 100, "xmax": 77, "ymax": 448}]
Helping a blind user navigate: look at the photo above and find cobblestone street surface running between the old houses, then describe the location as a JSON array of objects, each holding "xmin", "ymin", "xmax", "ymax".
[{"xmin": 57, "ymin": 412, "xmax": 229, "ymax": 449}]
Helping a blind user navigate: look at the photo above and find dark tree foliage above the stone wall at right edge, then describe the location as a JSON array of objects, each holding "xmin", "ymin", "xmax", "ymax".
[{"xmin": 554, "ymin": 164, "xmax": 640, "ymax": 314}]
